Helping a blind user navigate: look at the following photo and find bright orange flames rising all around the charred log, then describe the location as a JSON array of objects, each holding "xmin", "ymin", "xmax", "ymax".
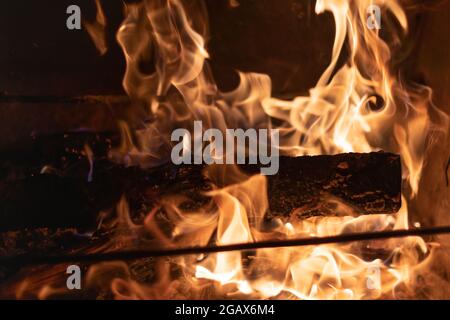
[{"xmin": 25, "ymin": 0, "xmax": 448, "ymax": 299}]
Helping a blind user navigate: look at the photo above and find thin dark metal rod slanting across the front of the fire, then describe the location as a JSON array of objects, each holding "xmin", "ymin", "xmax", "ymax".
[{"xmin": 0, "ymin": 226, "xmax": 450, "ymax": 266}]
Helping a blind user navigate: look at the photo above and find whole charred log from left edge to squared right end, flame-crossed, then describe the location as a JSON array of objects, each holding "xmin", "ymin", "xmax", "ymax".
[{"xmin": 0, "ymin": 133, "xmax": 401, "ymax": 231}]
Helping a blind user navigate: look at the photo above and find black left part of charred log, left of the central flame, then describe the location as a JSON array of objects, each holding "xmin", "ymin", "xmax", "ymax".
[{"xmin": 0, "ymin": 132, "xmax": 208, "ymax": 232}]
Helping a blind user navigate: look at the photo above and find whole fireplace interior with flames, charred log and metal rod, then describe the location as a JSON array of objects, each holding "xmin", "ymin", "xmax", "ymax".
[{"xmin": 0, "ymin": 0, "xmax": 450, "ymax": 299}]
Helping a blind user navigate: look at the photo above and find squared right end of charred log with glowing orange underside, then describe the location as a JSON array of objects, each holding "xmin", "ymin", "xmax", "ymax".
[{"xmin": 253, "ymin": 152, "xmax": 401, "ymax": 217}]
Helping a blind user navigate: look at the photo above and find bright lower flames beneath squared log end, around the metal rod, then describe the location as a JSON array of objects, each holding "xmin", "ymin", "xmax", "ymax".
[{"xmin": 169, "ymin": 172, "xmax": 428, "ymax": 299}]
